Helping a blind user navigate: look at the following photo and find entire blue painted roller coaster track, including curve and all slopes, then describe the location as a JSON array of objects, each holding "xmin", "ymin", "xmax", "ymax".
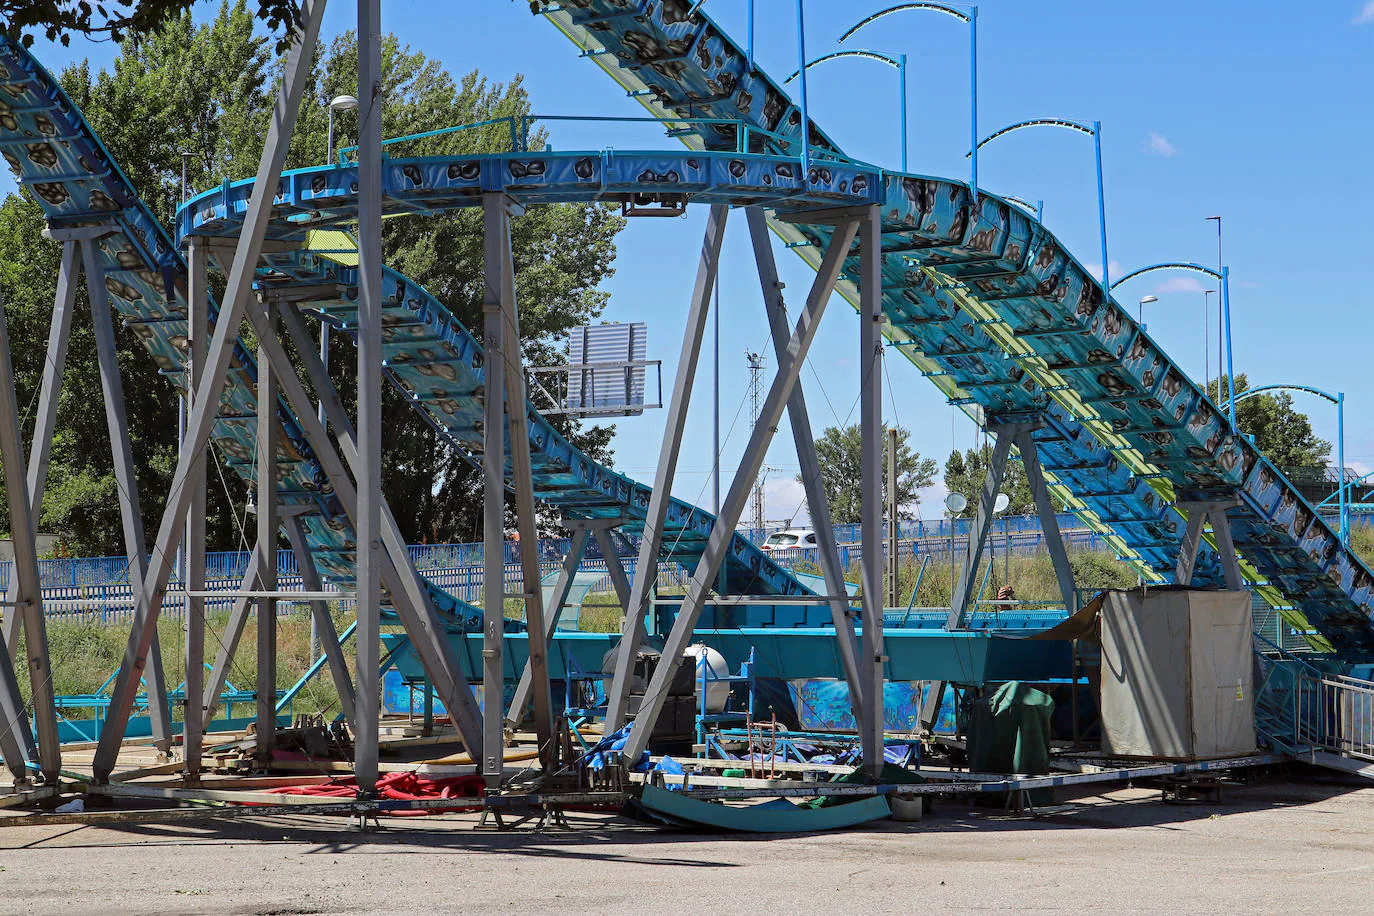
[{"xmin": 0, "ymin": 0, "xmax": 1374, "ymax": 659}]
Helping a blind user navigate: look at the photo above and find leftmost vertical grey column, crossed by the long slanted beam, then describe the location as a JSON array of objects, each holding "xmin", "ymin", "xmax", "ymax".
[{"xmin": 181, "ymin": 236, "xmax": 210, "ymax": 786}]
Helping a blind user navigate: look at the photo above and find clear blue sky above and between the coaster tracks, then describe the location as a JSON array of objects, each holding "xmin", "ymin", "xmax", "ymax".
[{"xmin": 16, "ymin": 0, "xmax": 1374, "ymax": 519}]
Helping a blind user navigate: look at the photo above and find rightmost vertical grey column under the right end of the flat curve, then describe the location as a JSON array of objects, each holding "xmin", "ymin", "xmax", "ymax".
[{"xmin": 845, "ymin": 206, "xmax": 888, "ymax": 777}]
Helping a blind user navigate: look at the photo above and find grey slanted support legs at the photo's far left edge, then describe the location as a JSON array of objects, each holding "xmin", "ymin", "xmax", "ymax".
[{"xmin": 0, "ymin": 292, "xmax": 62, "ymax": 786}]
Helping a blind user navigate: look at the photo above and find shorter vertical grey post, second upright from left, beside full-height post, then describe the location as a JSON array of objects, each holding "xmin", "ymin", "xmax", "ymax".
[{"xmin": 253, "ymin": 299, "xmax": 279, "ymax": 769}]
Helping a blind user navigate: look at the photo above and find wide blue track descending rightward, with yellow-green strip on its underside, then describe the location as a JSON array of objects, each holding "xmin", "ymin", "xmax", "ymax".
[{"xmin": 536, "ymin": 0, "xmax": 1374, "ymax": 659}]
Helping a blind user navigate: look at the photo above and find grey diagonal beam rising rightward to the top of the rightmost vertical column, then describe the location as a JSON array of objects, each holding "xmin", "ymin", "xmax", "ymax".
[{"xmin": 616, "ymin": 211, "xmax": 856, "ymax": 764}]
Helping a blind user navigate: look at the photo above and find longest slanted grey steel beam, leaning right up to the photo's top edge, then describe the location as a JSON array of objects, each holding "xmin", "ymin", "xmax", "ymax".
[{"xmin": 92, "ymin": 0, "xmax": 324, "ymax": 784}]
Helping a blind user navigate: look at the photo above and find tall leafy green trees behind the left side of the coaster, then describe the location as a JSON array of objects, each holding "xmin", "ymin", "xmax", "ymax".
[{"xmin": 0, "ymin": 0, "xmax": 624, "ymax": 553}]
